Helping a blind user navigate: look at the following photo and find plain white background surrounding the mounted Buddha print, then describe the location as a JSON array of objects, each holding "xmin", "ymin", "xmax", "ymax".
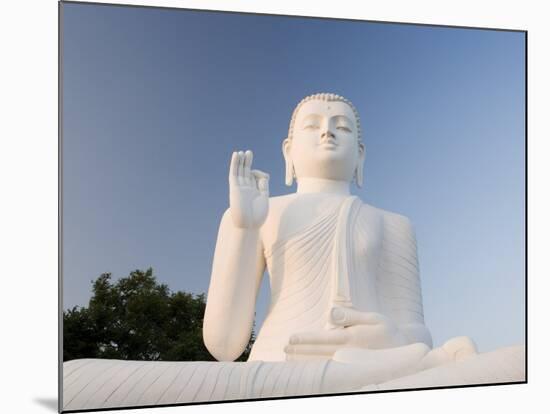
[{"xmin": 0, "ymin": 0, "xmax": 550, "ymax": 414}]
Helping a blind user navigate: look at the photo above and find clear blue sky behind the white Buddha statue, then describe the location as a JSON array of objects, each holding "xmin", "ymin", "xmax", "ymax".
[{"xmin": 63, "ymin": 4, "xmax": 525, "ymax": 351}]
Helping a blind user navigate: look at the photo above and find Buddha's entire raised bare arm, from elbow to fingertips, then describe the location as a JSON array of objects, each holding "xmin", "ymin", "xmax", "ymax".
[{"xmin": 203, "ymin": 151, "xmax": 269, "ymax": 361}]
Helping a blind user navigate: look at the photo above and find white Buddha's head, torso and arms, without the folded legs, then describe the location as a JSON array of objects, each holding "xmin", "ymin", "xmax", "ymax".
[{"xmin": 203, "ymin": 93, "xmax": 432, "ymax": 361}]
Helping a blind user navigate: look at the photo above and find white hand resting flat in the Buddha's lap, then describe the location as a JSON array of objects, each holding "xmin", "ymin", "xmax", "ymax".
[{"xmin": 285, "ymin": 307, "xmax": 407, "ymax": 360}]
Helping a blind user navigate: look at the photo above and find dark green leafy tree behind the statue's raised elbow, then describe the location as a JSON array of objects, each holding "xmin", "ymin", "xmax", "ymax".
[{"xmin": 63, "ymin": 269, "xmax": 254, "ymax": 361}]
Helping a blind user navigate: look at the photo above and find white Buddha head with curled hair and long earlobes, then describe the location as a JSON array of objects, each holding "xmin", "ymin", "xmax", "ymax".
[{"xmin": 283, "ymin": 93, "xmax": 365, "ymax": 187}]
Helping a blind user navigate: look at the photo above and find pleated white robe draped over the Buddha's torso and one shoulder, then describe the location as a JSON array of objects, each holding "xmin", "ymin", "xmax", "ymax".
[{"xmin": 250, "ymin": 196, "xmax": 424, "ymax": 361}]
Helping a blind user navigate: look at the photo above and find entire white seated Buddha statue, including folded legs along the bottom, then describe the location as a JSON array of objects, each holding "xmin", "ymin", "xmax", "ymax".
[{"xmin": 63, "ymin": 93, "xmax": 525, "ymax": 410}]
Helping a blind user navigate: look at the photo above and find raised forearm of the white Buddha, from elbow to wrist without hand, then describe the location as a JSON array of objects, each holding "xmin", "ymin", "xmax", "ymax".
[{"xmin": 203, "ymin": 209, "xmax": 265, "ymax": 361}]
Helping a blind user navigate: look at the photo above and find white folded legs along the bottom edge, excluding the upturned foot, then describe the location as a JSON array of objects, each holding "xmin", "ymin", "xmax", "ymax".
[{"xmin": 63, "ymin": 346, "xmax": 525, "ymax": 410}]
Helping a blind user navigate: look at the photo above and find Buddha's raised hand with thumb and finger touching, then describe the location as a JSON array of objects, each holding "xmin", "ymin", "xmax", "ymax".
[{"xmin": 229, "ymin": 151, "xmax": 269, "ymax": 229}]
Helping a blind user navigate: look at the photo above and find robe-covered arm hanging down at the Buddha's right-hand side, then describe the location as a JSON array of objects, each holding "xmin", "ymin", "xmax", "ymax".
[{"xmin": 378, "ymin": 213, "xmax": 432, "ymax": 347}]
